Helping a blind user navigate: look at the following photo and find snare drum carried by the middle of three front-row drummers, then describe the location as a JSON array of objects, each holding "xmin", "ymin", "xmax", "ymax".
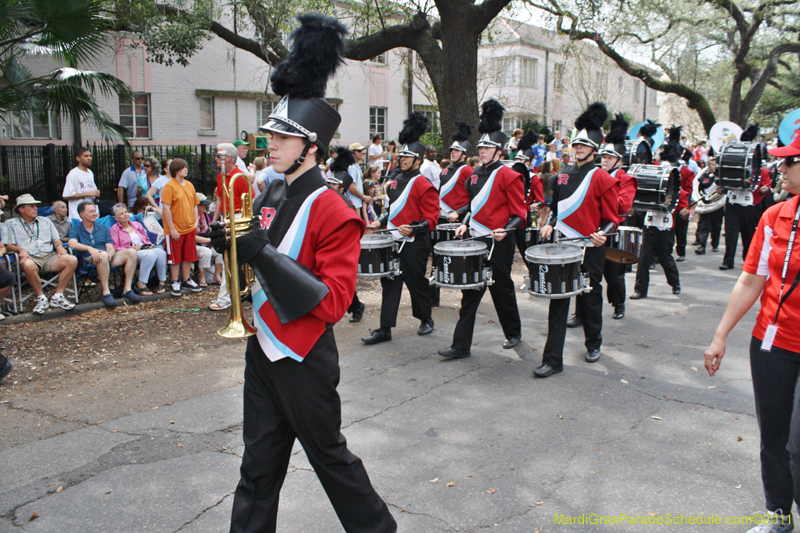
[{"xmin": 431, "ymin": 241, "xmax": 492, "ymax": 290}]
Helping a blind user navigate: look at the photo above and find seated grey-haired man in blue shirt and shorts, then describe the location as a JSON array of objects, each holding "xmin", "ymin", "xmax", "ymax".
[{"xmin": 69, "ymin": 202, "xmax": 141, "ymax": 307}]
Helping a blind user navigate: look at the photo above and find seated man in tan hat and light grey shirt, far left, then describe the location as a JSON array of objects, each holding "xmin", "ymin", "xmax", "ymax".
[{"xmin": 3, "ymin": 194, "xmax": 78, "ymax": 315}]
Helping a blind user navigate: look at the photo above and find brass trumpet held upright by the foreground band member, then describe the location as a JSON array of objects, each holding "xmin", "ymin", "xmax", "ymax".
[{"xmin": 217, "ymin": 172, "xmax": 256, "ymax": 339}]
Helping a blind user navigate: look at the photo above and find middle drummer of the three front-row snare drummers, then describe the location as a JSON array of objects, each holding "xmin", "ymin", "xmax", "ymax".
[{"xmin": 439, "ymin": 99, "xmax": 525, "ymax": 358}]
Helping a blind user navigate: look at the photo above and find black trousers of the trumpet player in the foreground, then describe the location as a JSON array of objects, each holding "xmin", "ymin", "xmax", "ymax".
[{"xmin": 231, "ymin": 328, "xmax": 395, "ymax": 533}]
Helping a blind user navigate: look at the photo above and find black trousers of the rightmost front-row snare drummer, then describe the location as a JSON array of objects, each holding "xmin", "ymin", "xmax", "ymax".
[{"xmin": 542, "ymin": 246, "xmax": 606, "ymax": 370}]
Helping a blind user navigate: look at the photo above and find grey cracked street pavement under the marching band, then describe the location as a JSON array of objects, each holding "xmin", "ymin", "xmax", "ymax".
[{"xmin": 0, "ymin": 249, "xmax": 776, "ymax": 533}]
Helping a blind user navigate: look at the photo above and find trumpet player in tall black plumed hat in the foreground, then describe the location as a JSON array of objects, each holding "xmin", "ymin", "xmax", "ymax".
[{"xmin": 220, "ymin": 14, "xmax": 397, "ymax": 533}]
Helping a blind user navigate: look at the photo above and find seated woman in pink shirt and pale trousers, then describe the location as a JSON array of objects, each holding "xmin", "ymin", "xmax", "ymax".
[{"xmin": 109, "ymin": 203, "xmax": 167, "ymax": 296}]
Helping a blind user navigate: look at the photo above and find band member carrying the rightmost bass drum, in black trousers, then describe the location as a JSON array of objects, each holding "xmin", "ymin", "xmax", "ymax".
[{"xmin": 719, "ymin": 125, "xmax": 772, "ymax": 270}]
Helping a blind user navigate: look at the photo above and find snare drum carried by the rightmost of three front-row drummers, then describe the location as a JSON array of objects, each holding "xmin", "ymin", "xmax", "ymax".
[{"xmin": 525, "ymin": 243, "xmax": 590, "ymax": 299}]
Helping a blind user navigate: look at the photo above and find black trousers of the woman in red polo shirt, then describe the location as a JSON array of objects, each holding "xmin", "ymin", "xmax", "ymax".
[{"xmin": 750, "ymin": 336, "xmax": 800, "ymax": 515}]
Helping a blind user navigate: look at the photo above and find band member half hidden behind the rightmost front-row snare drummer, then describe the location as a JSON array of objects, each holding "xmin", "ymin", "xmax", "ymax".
[{"xmin": 599, "ymin": 113, "xmax": 638, "ymax": 320}]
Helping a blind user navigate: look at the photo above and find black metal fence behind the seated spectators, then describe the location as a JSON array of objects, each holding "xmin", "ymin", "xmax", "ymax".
[{"xmin": 0, "ymin": 144, "xmax": 217, "ymax": 206}]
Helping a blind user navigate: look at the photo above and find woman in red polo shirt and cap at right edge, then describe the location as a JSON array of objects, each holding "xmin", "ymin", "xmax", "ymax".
[{"xmin": 704, "ymin": 130, "xmax": 800, "ymax": 533}]
